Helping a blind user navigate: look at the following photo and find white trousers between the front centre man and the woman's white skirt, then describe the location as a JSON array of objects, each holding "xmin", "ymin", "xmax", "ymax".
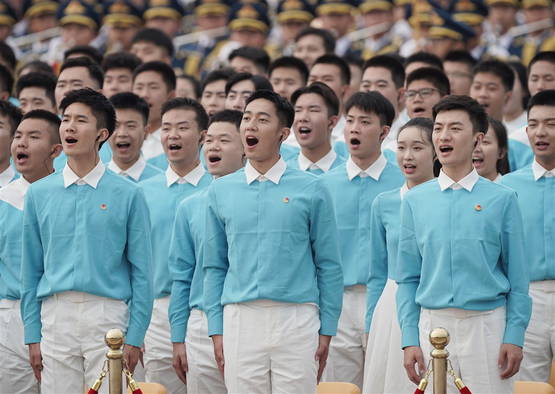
[{"xmin": 322, "ymin": 285, "xmax": 367, "ymax": 388}]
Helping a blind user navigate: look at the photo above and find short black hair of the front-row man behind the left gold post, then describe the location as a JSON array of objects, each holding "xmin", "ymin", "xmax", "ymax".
[{"xmin": 60, "ymin": 88, "xmax": 116, "ymax": 149}]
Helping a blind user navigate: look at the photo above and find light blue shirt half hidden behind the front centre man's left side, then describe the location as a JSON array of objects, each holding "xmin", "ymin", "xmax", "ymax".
[{"xmin": 169, "ymin": 189, "xmax": 208, "ymax": 343}]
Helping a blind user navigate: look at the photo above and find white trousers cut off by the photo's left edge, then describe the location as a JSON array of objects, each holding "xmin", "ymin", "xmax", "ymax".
[{"xmin": 0, "ymin": 300, "xmax": 39, "ymax": 394}]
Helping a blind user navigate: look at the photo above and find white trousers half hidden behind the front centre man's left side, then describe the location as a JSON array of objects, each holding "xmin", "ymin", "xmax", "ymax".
[{"xmin": 185, "ymin": 309, "xmax": 227, "ymax": 394}]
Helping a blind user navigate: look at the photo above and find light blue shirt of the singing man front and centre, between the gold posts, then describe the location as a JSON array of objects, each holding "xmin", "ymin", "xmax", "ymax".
[{"xmin": 203, "ymin": 159, "xmax": 343, "ymax": 335}]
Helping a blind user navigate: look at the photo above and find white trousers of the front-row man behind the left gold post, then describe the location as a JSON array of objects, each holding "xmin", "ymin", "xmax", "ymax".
[{"xmin": 40, "ymin": 291, "xmax": 129, "ymax": 394}]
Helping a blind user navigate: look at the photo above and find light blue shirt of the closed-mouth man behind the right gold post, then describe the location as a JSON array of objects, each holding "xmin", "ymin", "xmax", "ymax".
[{"xmin": 397, "ymin": 170, "xmax": 532, "ymax": 347}]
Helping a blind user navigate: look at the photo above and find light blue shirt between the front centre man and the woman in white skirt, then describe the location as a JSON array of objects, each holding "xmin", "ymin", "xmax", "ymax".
[{"xmin": 322, "ymin": 155, "xmax": 403, "ymax": 287}]
